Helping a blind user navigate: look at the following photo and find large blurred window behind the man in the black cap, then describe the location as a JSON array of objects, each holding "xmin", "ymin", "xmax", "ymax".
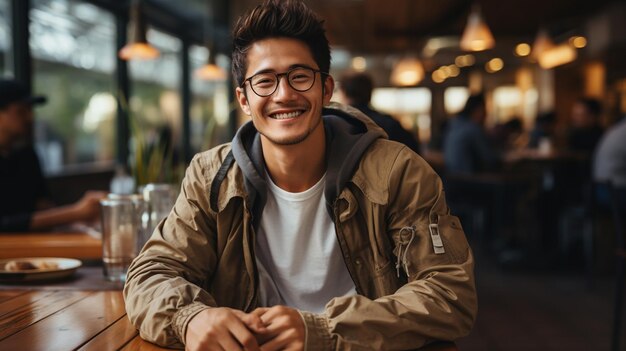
[{"xmin": 29, "ymin": 0, "xmax": 117, "ymax": 174}]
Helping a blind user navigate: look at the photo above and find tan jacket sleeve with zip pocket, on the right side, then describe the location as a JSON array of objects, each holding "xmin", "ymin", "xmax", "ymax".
[{"xmin": 301, "ymin": 148, "xmax": 477, "ymax": 350}]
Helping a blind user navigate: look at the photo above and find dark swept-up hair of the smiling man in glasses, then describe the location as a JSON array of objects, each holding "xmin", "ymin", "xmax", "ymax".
[{"xmin": 232, "ymin": 0, "xmax": 330, "ymax": 86}]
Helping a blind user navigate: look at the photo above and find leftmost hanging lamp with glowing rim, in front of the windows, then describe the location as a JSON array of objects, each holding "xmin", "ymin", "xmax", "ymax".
[{"xmin": 118, "ymin": 1, "xmax": 160, "ymax": 61}]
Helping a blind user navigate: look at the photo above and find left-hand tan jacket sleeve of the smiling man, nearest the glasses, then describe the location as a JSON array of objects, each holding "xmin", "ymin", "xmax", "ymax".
[{"xmin": 124, "ymin": 156, "xmax": 216, "ymax": 348}]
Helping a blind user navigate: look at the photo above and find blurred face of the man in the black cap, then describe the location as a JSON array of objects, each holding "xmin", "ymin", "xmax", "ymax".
[{"xmin": 0, "ymin": 103, "xmax": 33, "ymax": 143}]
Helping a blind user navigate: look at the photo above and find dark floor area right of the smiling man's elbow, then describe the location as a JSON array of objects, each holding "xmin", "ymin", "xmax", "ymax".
[{"xmin": 457, "ymin": 248, "xmax": 626, "ymax": 351}]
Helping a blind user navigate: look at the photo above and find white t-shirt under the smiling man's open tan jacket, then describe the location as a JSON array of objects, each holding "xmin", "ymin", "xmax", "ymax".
[{"xmin": 256, "ymin": 175, "xmax": 356, "ymax": 313}]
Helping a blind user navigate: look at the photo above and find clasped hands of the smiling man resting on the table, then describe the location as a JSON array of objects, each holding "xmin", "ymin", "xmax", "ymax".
[{"xmin": 185, "ymin": 306, "xmax": 305, "ymax": 351}]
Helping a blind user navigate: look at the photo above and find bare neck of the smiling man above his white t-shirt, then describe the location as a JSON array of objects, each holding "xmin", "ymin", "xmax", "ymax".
[{"xmin": 262, "ymin": 124, "xmax": 326, "ymax": 193}]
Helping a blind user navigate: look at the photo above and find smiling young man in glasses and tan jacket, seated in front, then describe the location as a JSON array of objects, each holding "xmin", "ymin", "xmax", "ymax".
[{"xmin": 124, "ymin": 0, "xmax": 476, "ymax": 350}]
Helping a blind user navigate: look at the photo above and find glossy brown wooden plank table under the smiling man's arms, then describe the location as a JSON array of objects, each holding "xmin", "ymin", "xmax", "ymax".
[{"xmin": 0, "ymin": 289, "xmax": 458, "ymax": 351}]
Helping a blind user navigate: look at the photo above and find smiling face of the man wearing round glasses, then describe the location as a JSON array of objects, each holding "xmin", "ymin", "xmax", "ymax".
[{"xmin": 236, "ymin": 38, "xmax": 334, "ymax": 145}]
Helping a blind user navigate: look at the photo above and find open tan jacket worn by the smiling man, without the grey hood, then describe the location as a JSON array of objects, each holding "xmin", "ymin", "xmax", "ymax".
[{"xmin": 124, "ymin": 106, "xmax": 477, "ymax": 350}]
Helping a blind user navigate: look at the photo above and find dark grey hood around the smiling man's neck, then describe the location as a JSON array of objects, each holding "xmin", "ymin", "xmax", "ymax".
[{"xmin": 232, "ymin": 103, "xmax": 387, "ymax": 221}]
